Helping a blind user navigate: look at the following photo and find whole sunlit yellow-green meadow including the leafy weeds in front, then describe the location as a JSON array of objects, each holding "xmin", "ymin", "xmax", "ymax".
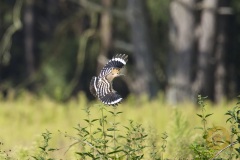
[{"xmin": 0, "ymin": 93, "xmax": 240, "ymax": 160}]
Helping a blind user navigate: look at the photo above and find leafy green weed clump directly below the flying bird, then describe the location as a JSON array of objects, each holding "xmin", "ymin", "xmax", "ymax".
[{"xmin": 60, "ymin": 105, "xmax": 147, "ymax": 159}]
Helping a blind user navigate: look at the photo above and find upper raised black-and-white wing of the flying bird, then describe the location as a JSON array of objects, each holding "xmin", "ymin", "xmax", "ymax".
[{"xmin": 99, "ymin": 54, "xmax": 128, "ymax": 78}]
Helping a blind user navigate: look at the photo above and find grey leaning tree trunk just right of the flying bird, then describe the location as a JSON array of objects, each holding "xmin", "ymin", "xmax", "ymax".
[{"xmin": 127, "ymin": 0, "xmax": 157, "ymax": 98}]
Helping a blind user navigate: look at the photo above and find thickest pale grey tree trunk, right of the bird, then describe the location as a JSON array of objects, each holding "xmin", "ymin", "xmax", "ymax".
[{"xmin": 166, "ymin": 0, "xmax": 195, "ymax": 104}]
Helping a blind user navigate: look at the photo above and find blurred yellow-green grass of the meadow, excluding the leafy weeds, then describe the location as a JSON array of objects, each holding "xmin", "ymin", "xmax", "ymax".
[{"xmin": 0, "ymin": 93, "xmax": 239, "ymax": 159}]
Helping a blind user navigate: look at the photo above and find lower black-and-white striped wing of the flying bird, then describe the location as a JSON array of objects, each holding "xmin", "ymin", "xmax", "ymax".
[{"xmin": 97, "ymin": 77, "xmax": 122, "ymax": 106}]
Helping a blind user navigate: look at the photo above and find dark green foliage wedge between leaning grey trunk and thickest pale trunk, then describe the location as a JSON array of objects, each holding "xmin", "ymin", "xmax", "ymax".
[{"xmin": 147, "ymin": 0, "xmax": 170, "ymax": 86}]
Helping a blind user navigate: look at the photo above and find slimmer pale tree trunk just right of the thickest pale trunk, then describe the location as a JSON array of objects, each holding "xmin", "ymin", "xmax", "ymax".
[{"xmin": 193, "ymin": 0, "xmax": 218, "ymax": 99}]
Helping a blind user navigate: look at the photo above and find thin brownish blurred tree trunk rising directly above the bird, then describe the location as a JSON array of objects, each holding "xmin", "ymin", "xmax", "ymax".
[{"xmin": 97, "ymin": 0, "xmax": 112, "ymax": 73}]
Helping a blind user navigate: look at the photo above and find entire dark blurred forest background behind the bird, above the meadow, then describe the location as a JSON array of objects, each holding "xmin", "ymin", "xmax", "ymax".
[{"xmin": 0, "ymin": 0, "xmax": 240, "ymax": 103}]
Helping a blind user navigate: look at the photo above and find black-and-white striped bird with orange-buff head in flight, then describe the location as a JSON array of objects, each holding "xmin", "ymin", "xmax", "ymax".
[{"xmin": 90, "ymin": 54, "xmax": 128, "ymax": 106}]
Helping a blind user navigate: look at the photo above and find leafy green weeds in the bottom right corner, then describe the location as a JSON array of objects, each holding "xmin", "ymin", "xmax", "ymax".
[{"xmin": 191, "ymin": 95, "xmax": 240, "ymax": 160}]
